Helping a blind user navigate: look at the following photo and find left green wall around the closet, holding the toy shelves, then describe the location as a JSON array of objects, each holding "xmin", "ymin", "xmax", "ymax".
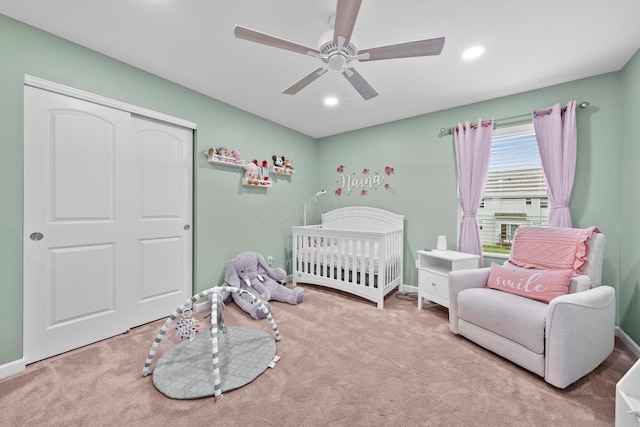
[{"xmin": 0, "ymin": 15, "xmax": 316, "ymax": 365}]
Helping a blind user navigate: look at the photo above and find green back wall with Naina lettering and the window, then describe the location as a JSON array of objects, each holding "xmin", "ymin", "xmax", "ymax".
[{"xmin": 318, "ymin": 73, "xmax": 620, "ymax": 300}]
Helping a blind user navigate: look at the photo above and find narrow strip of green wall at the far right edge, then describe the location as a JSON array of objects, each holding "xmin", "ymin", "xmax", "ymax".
[{"xmin": 617, "ymin": 51, "xmax": 640, "ymax": 344}]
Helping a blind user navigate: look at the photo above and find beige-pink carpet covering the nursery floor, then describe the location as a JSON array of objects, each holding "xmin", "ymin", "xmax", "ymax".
[{"xmin": 0, "ymin": 286, "xmax": 636, "ymax": 427}]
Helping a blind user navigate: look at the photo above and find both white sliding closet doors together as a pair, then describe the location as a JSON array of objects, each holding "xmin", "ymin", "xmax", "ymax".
[{"xmin": 24, "ymin": 86, "xmax": 192, "ymax": 363}]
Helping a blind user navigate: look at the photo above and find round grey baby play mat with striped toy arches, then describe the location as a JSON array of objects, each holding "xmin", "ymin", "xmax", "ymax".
[{"xmin": 142, "ymin": 286, "xmax": 280, "ymax": 400}]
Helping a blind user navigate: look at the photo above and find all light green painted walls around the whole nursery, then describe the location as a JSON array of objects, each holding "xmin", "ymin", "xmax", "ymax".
[{"xmin": 0, "ymin": 15, "xmax": 640, "ymax": 372}]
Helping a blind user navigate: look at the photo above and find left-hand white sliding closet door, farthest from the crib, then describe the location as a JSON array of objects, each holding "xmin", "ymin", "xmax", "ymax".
[{"xmin": 23, "ymin": 87, "xmax": 133, "ymax": 363}]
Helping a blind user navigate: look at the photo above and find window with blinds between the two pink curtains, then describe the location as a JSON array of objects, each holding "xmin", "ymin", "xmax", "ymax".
[{"xmin": 459, "ymin": 124, "xmax": 549, "ymax": 254}]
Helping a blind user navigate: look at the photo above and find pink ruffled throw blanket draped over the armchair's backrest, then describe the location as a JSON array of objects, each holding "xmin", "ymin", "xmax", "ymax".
[{"xmin": 509, "ymin": 227, "xmax": 600, "ymax": 276}]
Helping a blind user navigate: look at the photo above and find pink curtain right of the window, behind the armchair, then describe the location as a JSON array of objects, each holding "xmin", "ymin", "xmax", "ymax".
[{"xmin": 533, "ymin": 101, "xmax": 577, "ymax": 228}]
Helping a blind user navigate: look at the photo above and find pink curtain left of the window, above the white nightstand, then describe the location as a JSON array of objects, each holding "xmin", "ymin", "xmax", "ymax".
[{"xmin": 454, "ymin": 119, "xmax": 493, "ymax": 267}]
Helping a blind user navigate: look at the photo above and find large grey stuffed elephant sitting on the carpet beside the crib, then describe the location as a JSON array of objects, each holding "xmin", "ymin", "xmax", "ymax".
[{"xmin": 224, "ymin": 252, "xmax": 304, "ymax": 319}]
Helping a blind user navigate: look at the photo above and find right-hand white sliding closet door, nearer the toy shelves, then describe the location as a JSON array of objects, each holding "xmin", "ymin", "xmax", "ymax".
[{"xmin": 127, "ymin": 117, "xmax": 193, "ymax": 326}]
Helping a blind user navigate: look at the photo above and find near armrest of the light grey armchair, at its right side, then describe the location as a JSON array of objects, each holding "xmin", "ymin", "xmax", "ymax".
[{"xmin": 545, "ymin": 286, "xmax": 616, "ymax": 388}]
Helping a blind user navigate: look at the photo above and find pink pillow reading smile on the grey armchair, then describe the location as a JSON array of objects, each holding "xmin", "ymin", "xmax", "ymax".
[{"xmin": 487, "ymin": 263, "xmax": 571, "ymax": 303}]
